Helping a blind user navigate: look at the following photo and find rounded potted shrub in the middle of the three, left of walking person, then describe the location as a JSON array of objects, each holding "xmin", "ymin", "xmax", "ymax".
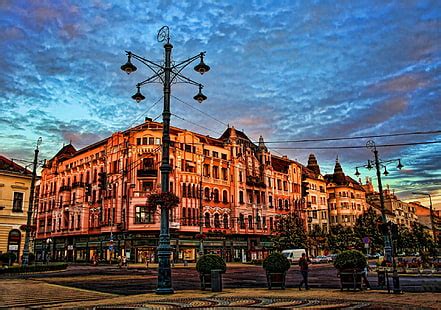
[{"xmin": 262, "ymin": 252, "xmax": 291, "ymax": 289}]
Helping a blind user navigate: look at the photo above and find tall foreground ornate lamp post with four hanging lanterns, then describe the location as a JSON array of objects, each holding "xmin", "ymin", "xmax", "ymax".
[{"xmin": 121, "ymin": 26, "xmax": 210, "ymax": 294}]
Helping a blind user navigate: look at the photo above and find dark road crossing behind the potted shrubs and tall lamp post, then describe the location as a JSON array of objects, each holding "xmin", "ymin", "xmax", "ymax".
[{"xmin": 7, "ymin": 264, "xmax": 441, "ymax": 295}]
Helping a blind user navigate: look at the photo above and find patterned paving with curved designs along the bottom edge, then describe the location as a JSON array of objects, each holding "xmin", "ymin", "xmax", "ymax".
[{"xmin": 43, "ymin": 289, "xmax": 441, "ymax": 309}]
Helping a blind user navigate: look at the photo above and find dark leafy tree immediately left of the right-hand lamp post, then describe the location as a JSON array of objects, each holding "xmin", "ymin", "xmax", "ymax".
[{"xmin": 354, "ymin": 208, "xmax": 384, "ymax": 253}]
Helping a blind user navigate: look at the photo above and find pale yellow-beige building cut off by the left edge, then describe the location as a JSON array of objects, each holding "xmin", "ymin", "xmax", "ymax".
[{"xmin": 0, "ymin": 155, "xmax": 32, "ymax": 259}]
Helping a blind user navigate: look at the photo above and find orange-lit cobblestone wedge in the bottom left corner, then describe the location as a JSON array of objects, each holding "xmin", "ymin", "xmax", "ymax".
[{"xmin": 0, "ymin": 279, "xmax": 114, "ymax": 308}]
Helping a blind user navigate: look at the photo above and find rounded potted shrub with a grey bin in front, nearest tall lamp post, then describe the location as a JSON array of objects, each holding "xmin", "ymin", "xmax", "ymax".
[{"xmin": 196, "ymin": 254, "xmax": 227, "ymax": 290}]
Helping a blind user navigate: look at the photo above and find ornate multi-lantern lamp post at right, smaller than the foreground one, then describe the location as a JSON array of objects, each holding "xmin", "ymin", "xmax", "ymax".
[{"xmin": 355, "ymin": 140, "xmax": 403, "ymax": 293}]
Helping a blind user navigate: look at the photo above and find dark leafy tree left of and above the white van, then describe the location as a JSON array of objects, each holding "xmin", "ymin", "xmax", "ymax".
[{"xmin": 272, "ymin": 213, "xmax": 306, "ymax": 251}]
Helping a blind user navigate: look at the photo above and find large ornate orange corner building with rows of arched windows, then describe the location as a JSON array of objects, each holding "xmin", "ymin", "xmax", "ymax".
[{"xmin": 36, "ymin": 119, "xmax": 305, "ymax": 262}]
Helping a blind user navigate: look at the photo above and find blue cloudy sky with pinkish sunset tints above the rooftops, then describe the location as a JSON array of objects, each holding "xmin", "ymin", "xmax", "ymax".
[{"xmin": 0, "ymin": 0, "xmax": 441, "ymax": 209}]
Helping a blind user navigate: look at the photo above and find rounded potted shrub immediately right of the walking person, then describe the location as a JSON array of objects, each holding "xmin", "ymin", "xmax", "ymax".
[{"xmin": 334, "ymin": 250, "xmax": 367, "ymax": 290}]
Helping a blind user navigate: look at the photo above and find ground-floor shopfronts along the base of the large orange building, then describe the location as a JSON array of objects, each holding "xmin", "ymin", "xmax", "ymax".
[{"xmin": 34, "ymin": 232, "xmax": 272, "ymax": 263}]
